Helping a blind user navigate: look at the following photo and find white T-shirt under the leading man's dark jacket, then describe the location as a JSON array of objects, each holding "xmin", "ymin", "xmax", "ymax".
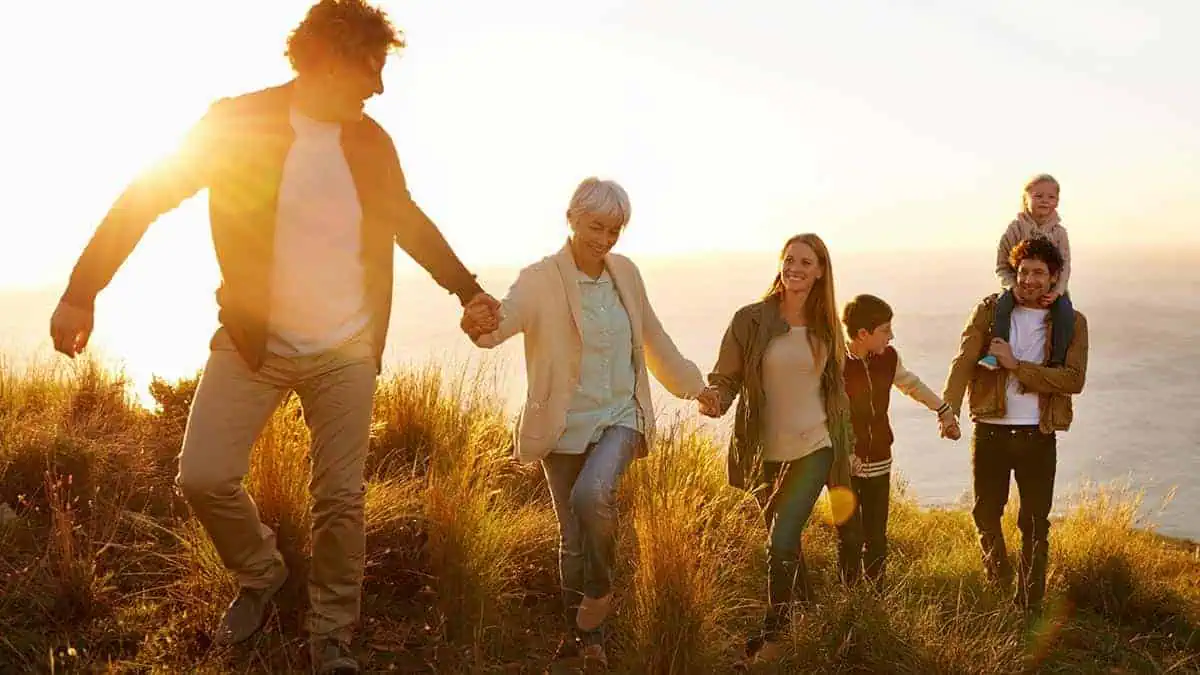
[{"xmin": 269, "ymin": 110, "xmax": 370, "ymax": 356}]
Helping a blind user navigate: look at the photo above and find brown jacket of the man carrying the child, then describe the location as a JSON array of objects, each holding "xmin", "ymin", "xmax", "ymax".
[{"xmin": 942, "ymin": 294, "xmax": 1087, "ymax": 434}]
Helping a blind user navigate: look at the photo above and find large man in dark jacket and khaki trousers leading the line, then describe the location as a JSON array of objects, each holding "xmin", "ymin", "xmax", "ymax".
[{"xmin": 50, "ymin": 0, "xmax": 499, "ymax": 673}]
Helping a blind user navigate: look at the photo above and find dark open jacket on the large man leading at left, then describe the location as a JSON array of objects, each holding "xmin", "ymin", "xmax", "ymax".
[{"xmin": 62, "ymin": 83, "xmax": 481, "ymax": 370}]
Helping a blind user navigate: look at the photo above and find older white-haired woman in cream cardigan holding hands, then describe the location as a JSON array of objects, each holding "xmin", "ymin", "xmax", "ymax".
[{"xmin": 462, "ymin": 178, "xmax": 704, "ymax": 663}]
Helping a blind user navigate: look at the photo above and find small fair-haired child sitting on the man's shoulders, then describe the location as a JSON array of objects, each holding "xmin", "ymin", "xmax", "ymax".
[{"xmin": 979, "ymin": 173, "xmax": 1075, "ymax": 370}]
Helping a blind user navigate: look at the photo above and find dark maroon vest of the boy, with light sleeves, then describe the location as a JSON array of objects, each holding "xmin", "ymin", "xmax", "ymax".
[{"xmin": 845, "ymin": 347, "xmax": 899, "ymax": 462}]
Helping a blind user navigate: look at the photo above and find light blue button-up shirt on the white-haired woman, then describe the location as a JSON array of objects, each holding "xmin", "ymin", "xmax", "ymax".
[{"xmin": 554, "ymin": 264, "xmax": 642, "ymax": 454}]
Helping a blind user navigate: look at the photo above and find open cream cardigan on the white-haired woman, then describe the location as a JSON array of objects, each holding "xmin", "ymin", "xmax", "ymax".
[{"xmin": 475, "ymin": 246, "xmax": 704, "ymax": 464}]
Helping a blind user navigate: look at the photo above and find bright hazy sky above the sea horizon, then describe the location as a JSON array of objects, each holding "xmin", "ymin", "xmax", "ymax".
[{"xmin": 0, "ymin": 0, "xmax": 1200, "ymax": 293}]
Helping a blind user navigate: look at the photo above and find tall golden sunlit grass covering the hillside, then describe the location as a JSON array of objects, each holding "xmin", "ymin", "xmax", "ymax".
[{"xmin": 0, "ymin": 362, "xmax": 1200, "ymax": 674}]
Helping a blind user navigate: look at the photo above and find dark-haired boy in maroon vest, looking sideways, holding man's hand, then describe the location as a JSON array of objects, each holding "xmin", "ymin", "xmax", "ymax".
[{"xmin": 841, "ymin": 295, "xmax": 961, "ymax": 584}]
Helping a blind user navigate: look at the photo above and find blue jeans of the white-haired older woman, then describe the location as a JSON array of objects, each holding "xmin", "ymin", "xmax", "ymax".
[{"xmin": 541, "ymin": 426, "xmax": 642, "ymax": 638}]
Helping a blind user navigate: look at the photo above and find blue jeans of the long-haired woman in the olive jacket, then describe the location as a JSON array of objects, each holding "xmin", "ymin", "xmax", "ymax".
[{"xmin": 762, "ymin": 448, "xmax": 833, "ymax": 638}]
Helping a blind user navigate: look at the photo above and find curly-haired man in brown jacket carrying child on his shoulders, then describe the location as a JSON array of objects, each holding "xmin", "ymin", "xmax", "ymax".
[{"xmin": 941, "ymin": 237, "xmax": 1087, "ymax": 613}]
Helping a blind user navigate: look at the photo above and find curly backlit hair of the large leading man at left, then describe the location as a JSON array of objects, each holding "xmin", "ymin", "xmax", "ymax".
[{"xmin": 286, "ymin": 0, "xmax": 404, "ymax": 73}]
